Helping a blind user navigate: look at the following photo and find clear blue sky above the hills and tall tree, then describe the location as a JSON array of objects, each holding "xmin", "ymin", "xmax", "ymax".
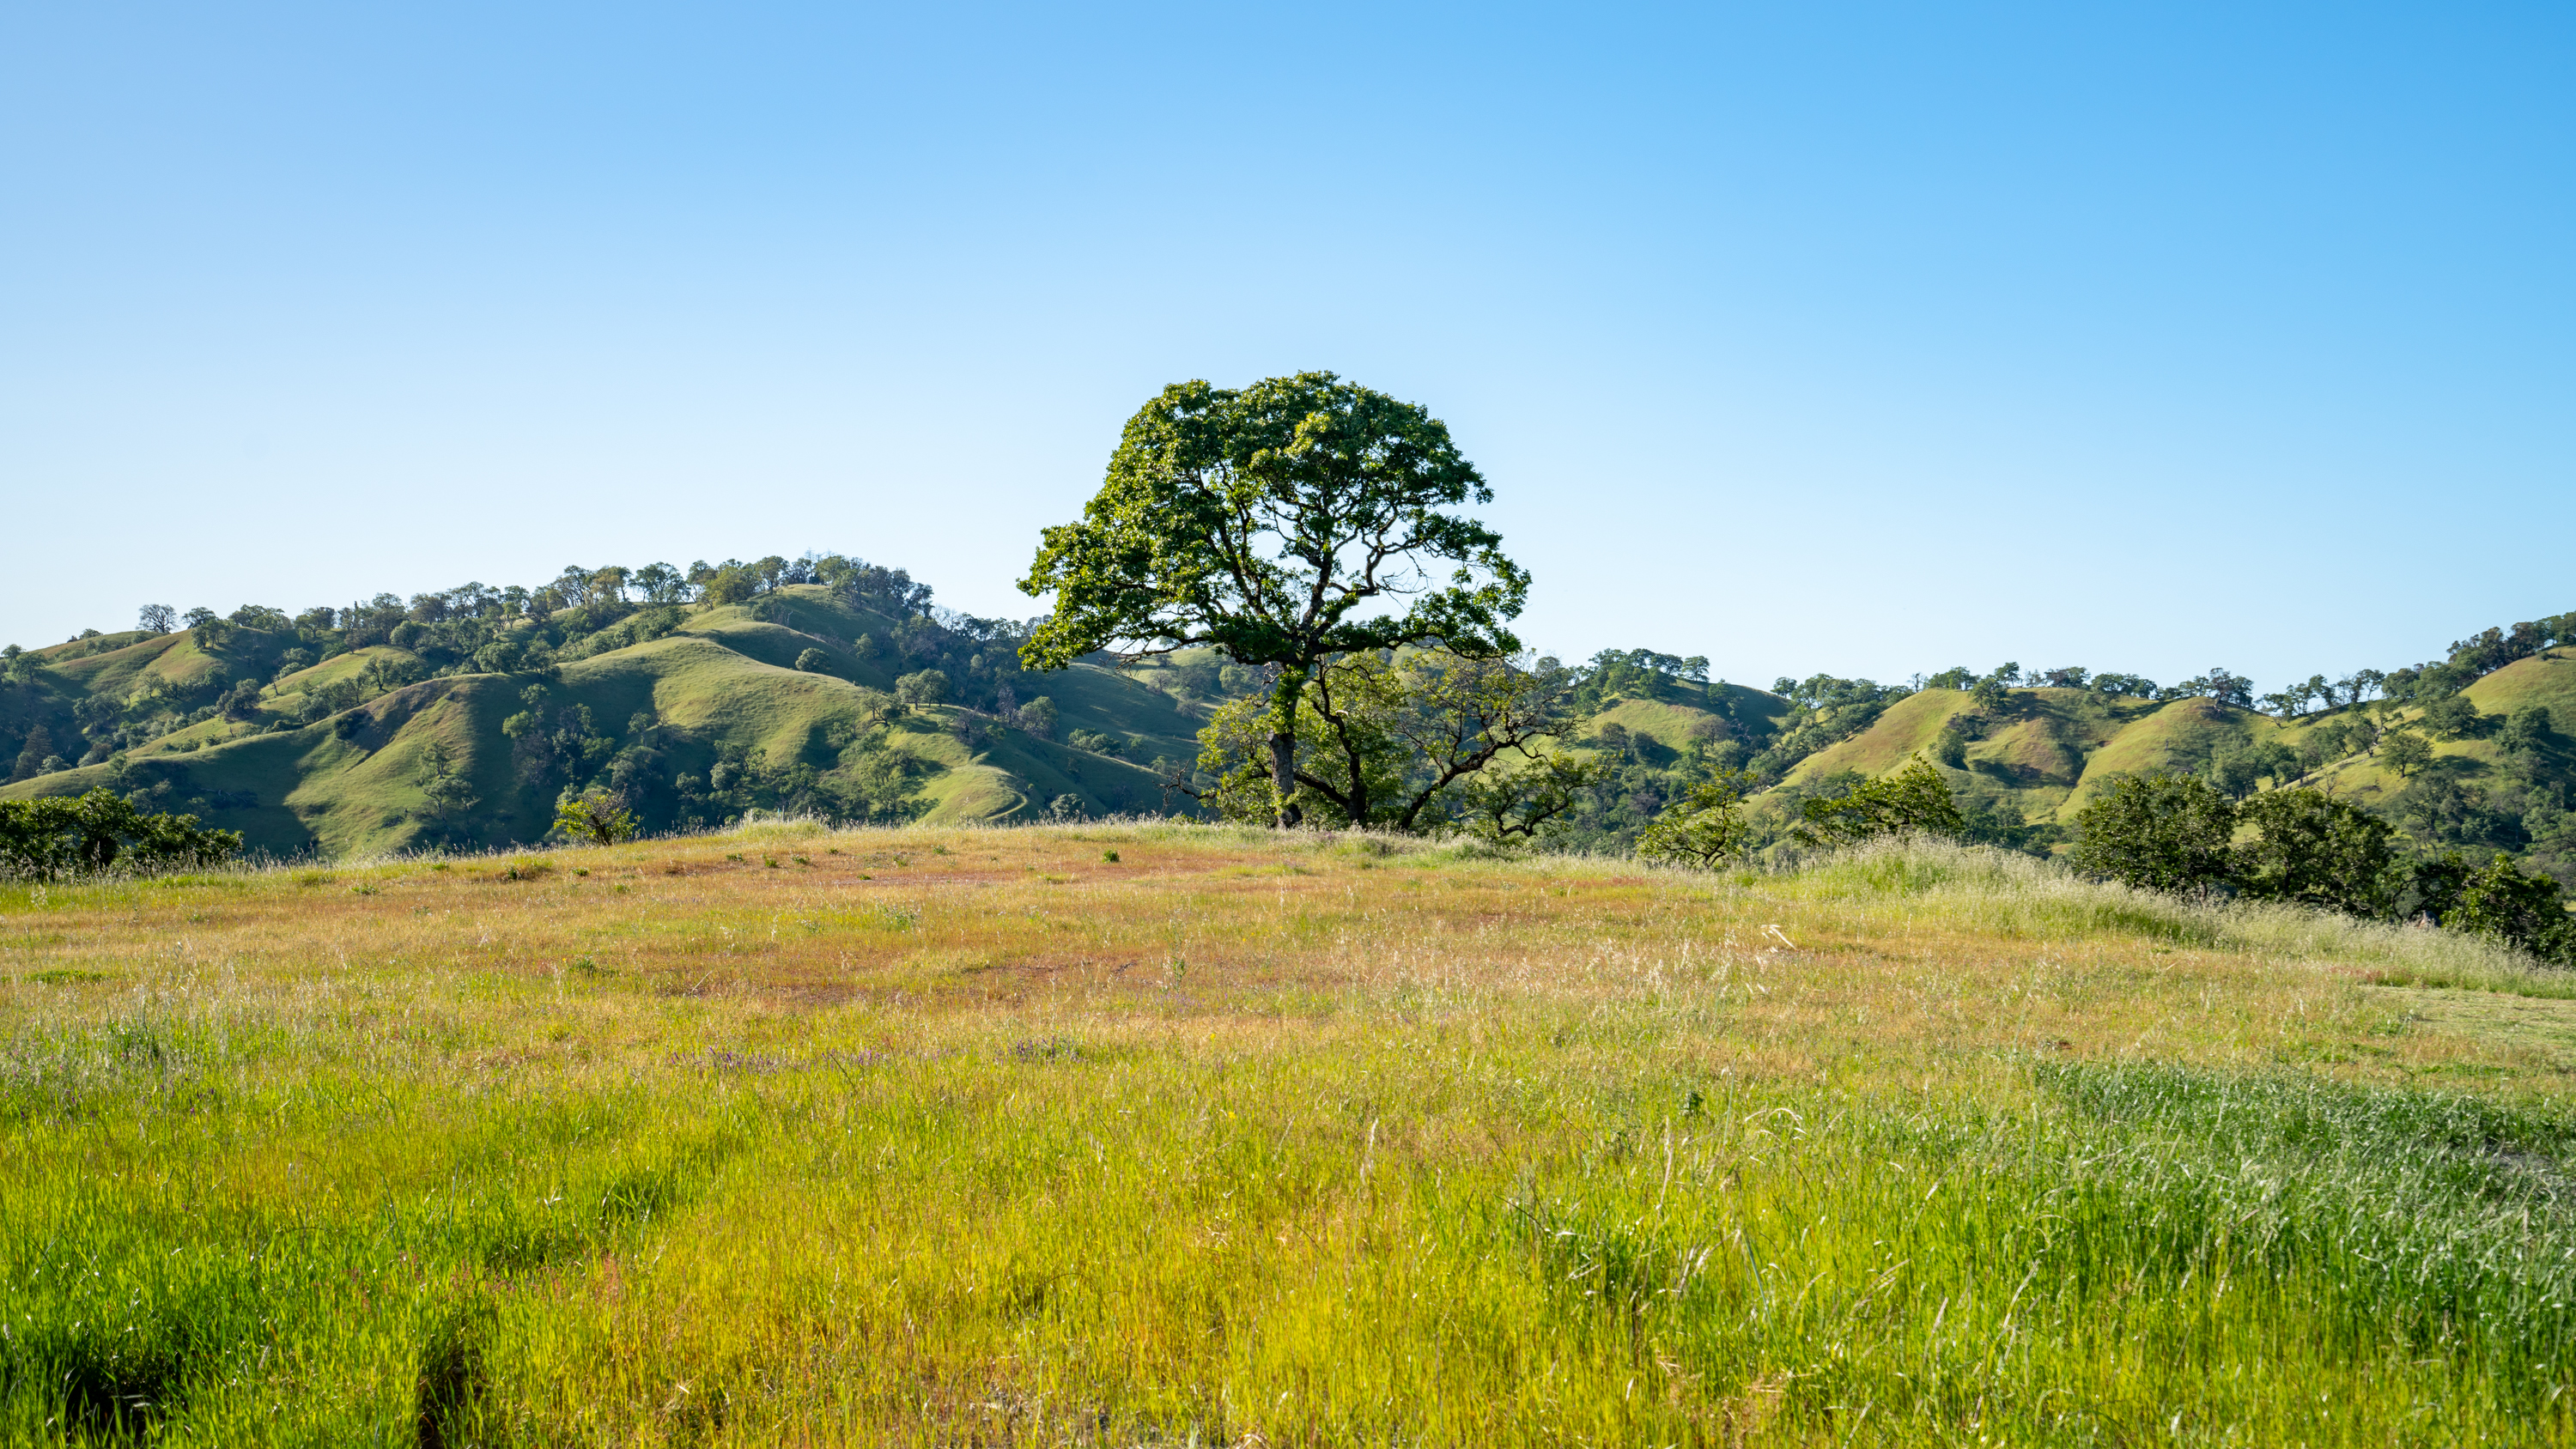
[{"xmin": 0, "ymin": 0, "xmax": 2576, "ymax": 688}]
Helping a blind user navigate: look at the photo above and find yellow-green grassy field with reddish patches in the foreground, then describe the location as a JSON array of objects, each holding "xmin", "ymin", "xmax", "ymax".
[{"xmin": 0, "ymin": 826, "xmax": 2576, "ymax": 1446}]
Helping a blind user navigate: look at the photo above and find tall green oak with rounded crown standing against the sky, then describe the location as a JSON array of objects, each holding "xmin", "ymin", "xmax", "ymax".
[{"xmin": 1020, "ymin": 373, "xmax": 1530, "ymax": 826}]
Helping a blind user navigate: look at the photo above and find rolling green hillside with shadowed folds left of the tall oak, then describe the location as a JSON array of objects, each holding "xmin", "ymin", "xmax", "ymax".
[{"xmin": 0, "ymin": 582, "xmax": 1198, "ymax": 854}]
